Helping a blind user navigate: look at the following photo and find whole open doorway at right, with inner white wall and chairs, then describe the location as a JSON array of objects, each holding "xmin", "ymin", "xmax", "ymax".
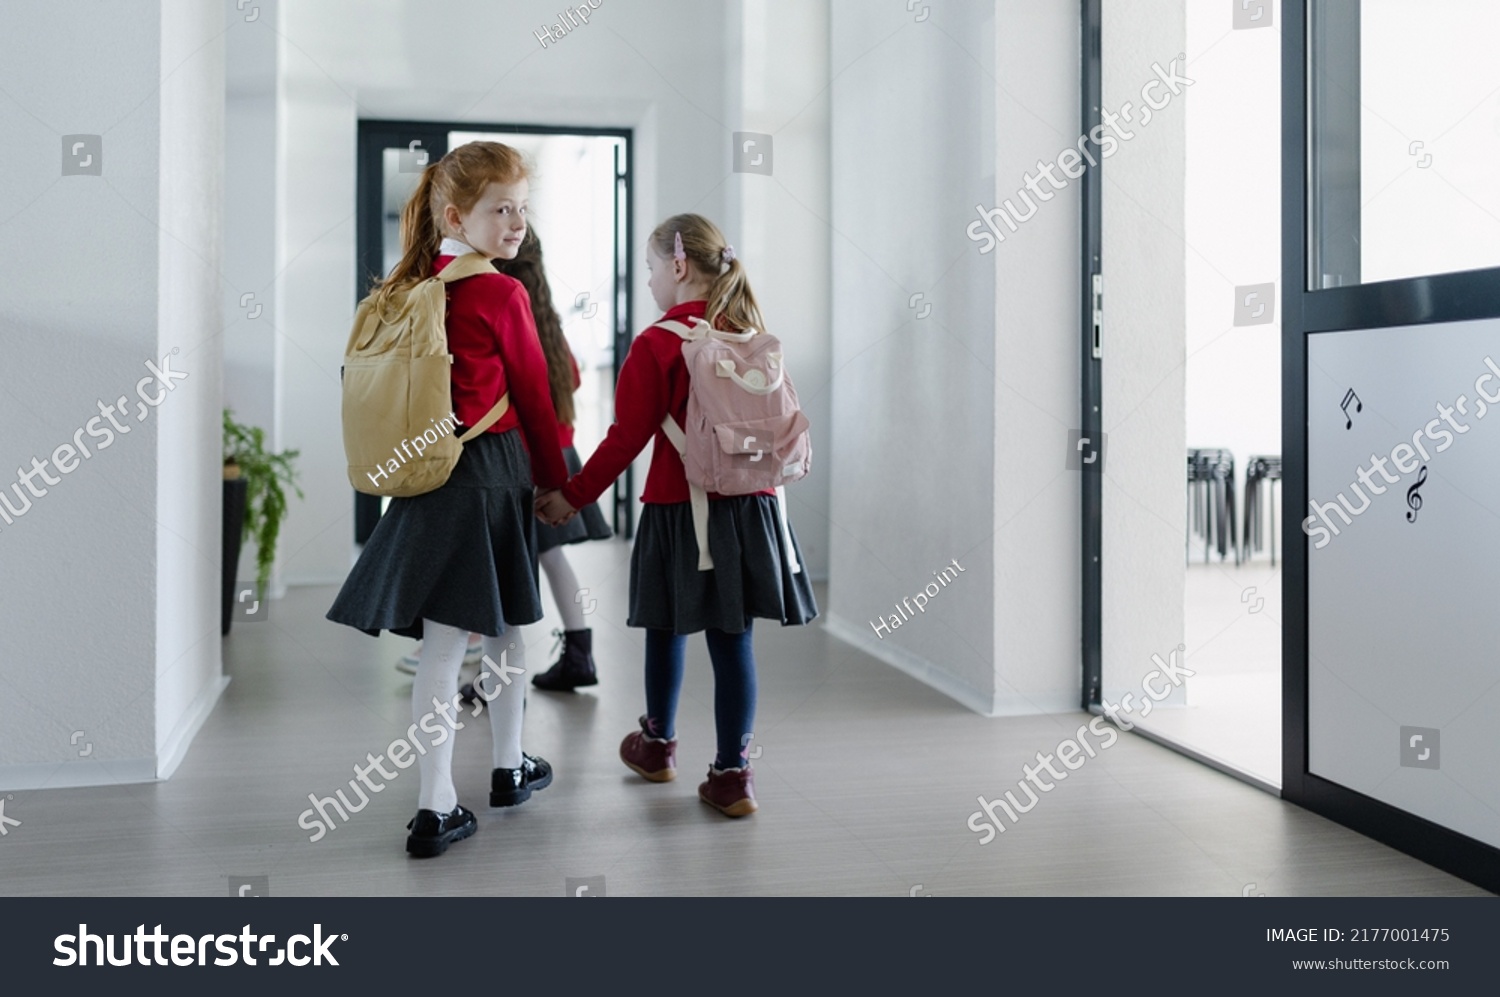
[{"xmin": 1083, "ymin": 0, "xmax": 1284, "ymax": 792}]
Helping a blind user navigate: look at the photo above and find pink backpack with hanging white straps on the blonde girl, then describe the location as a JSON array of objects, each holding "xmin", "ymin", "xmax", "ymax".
[{"xmin": 657, "ymin": 319, "xmax": 813, "ymax": 573}]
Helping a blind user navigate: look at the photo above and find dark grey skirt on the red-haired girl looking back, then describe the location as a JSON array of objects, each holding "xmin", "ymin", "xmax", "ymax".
[{"xmin": 329, "ymin": 429, "xmax": 542, "ymax": 640}]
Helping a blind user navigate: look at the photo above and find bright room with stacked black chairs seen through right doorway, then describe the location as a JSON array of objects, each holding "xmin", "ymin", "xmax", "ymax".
[{"xmin": 1142, "ymin": 1, "xmax": 1286, "ymax": 787}]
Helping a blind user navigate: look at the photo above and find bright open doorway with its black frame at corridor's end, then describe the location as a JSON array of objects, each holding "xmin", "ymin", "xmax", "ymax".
[{"xmin": 354, "ymin": 121, "xmax": 635, "ymax": 544}]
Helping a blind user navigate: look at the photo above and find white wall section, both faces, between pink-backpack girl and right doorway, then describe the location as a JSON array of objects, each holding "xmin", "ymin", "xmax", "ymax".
[{"xmin": 828, "ymin": 0, "xmax": 1079, "ymax": 714}]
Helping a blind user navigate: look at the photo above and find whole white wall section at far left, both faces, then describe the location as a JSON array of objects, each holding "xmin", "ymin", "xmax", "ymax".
[{"xmin": 0, "ymin": 0, "xmax": 224, "ymax": 789}]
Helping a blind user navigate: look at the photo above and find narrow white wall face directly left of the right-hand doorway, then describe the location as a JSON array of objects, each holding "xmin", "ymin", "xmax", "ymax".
[{"xmin": 996, "ymin": 0, "xmax": 1082, "ymax": 714}]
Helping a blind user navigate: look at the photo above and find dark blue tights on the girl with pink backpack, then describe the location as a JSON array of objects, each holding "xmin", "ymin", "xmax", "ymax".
[{"xmin": 647, "ymin": 624, "xmax": 756, "ymax": 769}]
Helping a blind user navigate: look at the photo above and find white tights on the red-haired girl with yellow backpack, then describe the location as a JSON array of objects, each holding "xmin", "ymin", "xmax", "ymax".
[{"xmin": 411, "ymin": 619, "xmax": 527, "ymax": 814}]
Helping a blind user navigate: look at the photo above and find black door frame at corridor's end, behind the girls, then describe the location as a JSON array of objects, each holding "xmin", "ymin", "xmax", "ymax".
[{"xmin": 354, "ymin": 118, "xmax": 636, "ymax": 544}]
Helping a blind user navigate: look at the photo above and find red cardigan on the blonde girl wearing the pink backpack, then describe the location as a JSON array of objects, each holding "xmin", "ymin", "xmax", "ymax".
[{"xmin": 563, "ymin": 301, "xmax": 776, "ymax": 508}]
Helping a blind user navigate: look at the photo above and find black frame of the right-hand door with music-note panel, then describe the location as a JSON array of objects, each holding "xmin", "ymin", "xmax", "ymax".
[{"xmin": 1281, "ymin": 0, "xmax": 1500, "ymax": 892}]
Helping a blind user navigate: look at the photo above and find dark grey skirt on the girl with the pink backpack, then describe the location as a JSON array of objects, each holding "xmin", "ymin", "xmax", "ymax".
[{"xmin": 627, "ymin": 495, "xmax": 818, "ymax": 634}]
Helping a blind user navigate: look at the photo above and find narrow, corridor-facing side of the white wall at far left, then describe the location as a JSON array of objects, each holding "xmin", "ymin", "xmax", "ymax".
[{"xmin": 156, "ymin": 0, "xmax": 228, "ymax": 777}]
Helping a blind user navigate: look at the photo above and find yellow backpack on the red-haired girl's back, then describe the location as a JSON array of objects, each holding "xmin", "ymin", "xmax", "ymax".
[{"xmin": 342, "ymin": 253, "xmax": 510, "ymax": 498}]
